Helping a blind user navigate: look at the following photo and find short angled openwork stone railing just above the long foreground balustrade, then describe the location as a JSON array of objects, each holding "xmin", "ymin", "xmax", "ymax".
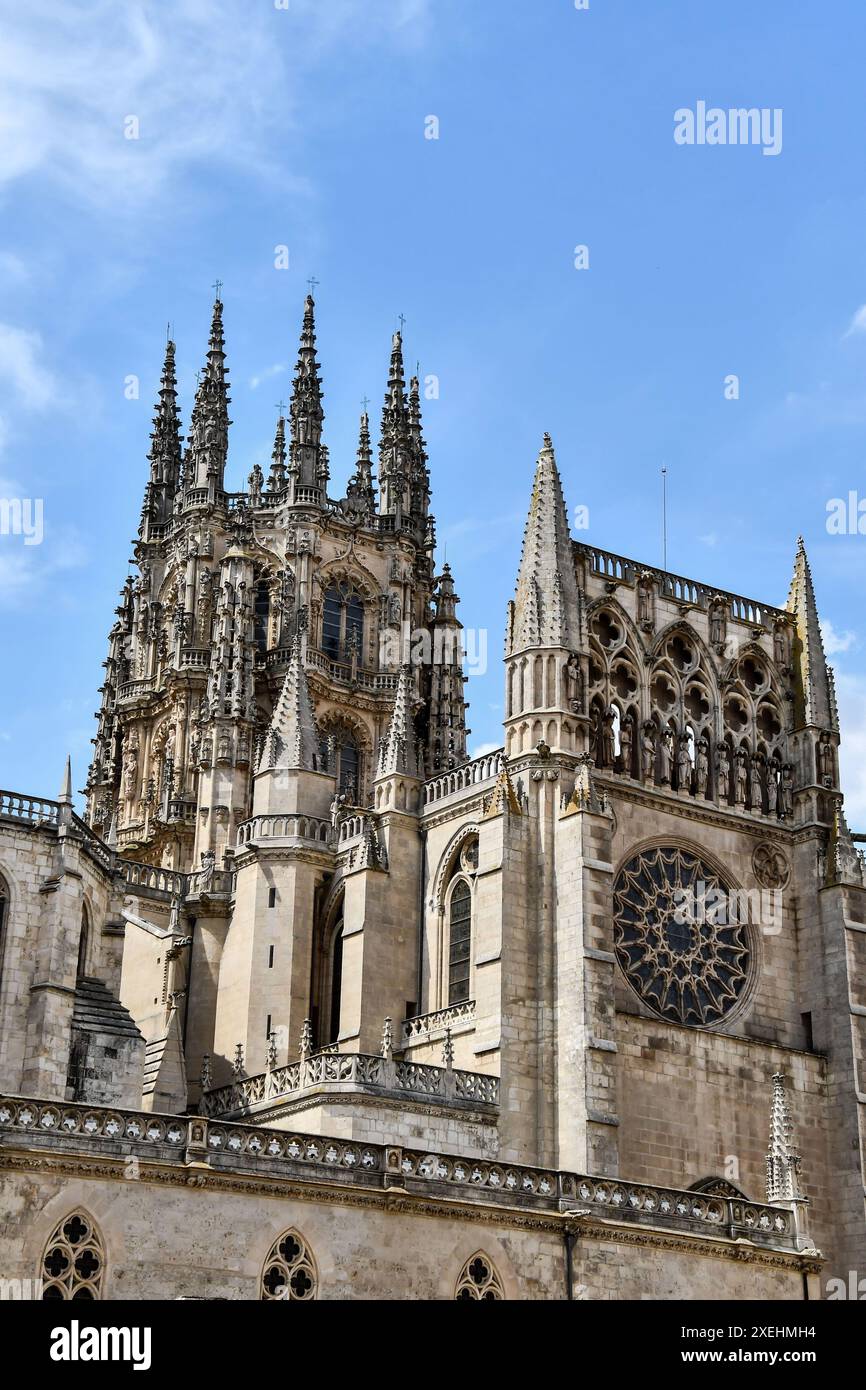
[{"xmin": 199, "ymin": 1051, "xmax": 499, "ymax": 1118}]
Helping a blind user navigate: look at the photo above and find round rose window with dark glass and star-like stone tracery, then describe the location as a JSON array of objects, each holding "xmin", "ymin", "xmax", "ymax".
[{"xmin": 613, "ymin": 845, "xmax": 749, "ymax": 1026}]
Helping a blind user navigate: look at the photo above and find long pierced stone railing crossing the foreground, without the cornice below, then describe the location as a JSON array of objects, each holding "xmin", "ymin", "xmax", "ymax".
[{"xmin": 0, "ymin": 1095, "xmax": 812, "ymax": 1258}]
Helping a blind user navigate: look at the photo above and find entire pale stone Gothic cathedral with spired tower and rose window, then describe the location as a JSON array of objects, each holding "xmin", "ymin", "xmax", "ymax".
[{"xmin": 0, "ymin": 291, "xmax": 866, "ymax": 1301}]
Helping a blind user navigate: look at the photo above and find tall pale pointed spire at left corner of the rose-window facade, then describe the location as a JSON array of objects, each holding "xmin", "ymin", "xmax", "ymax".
[{"xmin": 507, "ymin": 435, "xmax": 580, "ymax": 655}]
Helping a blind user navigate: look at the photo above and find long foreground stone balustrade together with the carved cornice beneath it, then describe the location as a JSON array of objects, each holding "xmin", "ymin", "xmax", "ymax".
[{"xmin": 0, "ymin": 1097, "xmax": 822, "ymax": 1268}]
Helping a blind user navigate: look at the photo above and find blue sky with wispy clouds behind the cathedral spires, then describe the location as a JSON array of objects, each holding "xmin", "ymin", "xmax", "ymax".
[{"xmin": 0, "ymin": 0, "xmax": 866, "ymax": 827}]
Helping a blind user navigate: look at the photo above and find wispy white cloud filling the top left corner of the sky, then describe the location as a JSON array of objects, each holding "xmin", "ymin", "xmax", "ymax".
[{"xmin": 0, "ymin": 0, "xmax": 430, "ymax": 215}]
